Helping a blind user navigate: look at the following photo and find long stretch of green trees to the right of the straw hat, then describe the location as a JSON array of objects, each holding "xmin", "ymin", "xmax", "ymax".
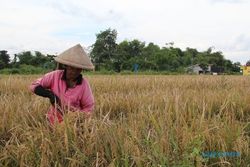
[{"xmin": 91, "ymin": 28, "xmax": 240, "ymax": 73}]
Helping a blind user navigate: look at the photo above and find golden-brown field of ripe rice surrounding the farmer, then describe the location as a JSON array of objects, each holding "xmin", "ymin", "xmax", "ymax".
[{"xmin": 0, "ymin": 75, "xmax": 250, "ymax": 167}]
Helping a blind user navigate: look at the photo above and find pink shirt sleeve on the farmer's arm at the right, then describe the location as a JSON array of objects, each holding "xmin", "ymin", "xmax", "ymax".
[{"xmin": 81, "ymin": 80, "xmax": 94, "ymax": 112}]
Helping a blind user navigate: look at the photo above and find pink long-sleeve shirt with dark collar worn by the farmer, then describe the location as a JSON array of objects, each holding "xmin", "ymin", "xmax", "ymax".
[{"xmin": 30, "ymin": 70, "xmax": 94, "ymax": 125}]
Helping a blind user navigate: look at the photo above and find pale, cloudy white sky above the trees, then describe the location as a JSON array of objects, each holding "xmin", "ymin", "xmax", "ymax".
[{"xmin": 0, "ymin": 0, "xmax": 250, "ymax": 64}]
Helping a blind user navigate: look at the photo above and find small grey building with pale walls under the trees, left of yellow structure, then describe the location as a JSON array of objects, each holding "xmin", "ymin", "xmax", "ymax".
[{"xmin": 187, "ymin": 64, "xmax": 224, "ymax": 75}]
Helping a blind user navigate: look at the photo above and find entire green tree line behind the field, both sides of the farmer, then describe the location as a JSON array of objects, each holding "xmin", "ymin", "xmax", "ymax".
[{"xmin": 0, "ymin": 28, "xmax": 244, "ymax": 73}]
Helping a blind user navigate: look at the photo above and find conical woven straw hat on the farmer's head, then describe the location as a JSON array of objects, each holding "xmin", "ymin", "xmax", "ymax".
[{"xmin": 55, "ymin": 44, "xmax": 95, "ymax": 70}]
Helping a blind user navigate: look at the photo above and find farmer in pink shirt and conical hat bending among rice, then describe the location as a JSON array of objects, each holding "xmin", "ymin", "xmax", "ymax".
[{"xmin": 30, "ymin": 44, "xmax": 94, "ymax": 125}]
